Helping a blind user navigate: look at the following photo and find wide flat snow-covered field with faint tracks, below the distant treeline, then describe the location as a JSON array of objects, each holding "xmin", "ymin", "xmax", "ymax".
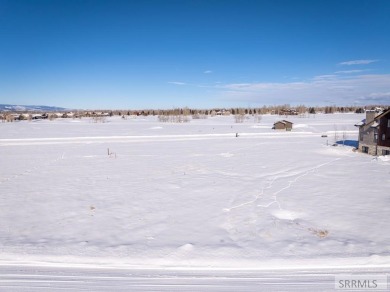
[{"xmin": 0, "ymin": 114, "xmax": 390, "ymax": 291}]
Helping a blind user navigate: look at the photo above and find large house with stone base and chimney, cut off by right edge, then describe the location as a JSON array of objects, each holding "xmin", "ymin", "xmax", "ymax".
[{"xmin": 355, "ymin": 108, "xmax": 390, "ymax": 155}]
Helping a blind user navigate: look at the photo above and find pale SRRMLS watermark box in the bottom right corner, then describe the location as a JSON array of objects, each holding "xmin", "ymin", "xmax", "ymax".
[{"xmin": 335, "ymin": 275, "xmax": 388, "ymax": 291}]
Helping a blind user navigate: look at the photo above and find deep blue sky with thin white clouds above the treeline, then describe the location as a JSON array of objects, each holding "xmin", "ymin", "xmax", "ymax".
[{"xmin": 0, "ymin": 0, "xmax": 390, "ymax": 109}]
